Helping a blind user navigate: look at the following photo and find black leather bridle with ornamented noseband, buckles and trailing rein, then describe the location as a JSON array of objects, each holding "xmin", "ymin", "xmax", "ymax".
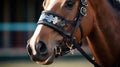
[{"xmin": 38, "ymin": 0, "xmax": 100, "ymax": 67}]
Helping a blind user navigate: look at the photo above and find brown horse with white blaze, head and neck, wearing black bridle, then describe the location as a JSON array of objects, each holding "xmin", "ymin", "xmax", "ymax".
[{"xmin": 27, "ymin": 0, "xmax": 120, "ymax": 67}]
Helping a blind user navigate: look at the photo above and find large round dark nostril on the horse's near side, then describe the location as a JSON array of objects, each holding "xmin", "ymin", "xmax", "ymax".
[{"xmin": 35, "ymin": 41, "xmax": 47, "ymax": 55}]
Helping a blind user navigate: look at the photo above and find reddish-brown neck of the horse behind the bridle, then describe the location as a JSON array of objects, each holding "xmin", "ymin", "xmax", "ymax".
[{"xmin": 87, "ymin": 0, "xmax": 120, "ymax": 67}]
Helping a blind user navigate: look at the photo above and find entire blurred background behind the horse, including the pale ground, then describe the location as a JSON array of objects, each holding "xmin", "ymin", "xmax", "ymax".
[{"xmin": 0, "ymin": 0, "xmax": 93, "ymax": 67}]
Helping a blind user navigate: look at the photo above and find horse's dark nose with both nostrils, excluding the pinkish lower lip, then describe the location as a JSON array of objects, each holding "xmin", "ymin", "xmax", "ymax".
[{"xmin": 27, "ymin": 41, "xmax": 49, "ymax": 61}]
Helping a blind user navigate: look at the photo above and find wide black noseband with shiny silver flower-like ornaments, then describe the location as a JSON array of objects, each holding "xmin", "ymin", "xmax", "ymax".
[{"xmin": 38, "ymin": 11, "xmax": 74, "ymax": 37}]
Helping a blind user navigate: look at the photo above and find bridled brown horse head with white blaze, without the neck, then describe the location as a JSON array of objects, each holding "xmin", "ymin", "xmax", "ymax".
[{"xmin": 27, "ymin": 0, "xmax": 93, "ymax": 64}]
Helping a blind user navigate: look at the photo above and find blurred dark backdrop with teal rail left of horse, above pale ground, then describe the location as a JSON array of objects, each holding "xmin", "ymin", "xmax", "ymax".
[{"xmin": 0, "ymin": 0, "xmax": 43, "ymax": 61}]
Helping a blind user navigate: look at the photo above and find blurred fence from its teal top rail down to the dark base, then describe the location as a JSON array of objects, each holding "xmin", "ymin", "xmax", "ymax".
[{"xmin": 0, "ymin": 22, "xmax": 36, "ymax": 61}]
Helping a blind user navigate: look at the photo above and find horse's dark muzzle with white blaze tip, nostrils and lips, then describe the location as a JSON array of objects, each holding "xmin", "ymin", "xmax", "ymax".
[{"xmin": 27, "ymin": 41, "xmax": 54, "ymax": 65}]
